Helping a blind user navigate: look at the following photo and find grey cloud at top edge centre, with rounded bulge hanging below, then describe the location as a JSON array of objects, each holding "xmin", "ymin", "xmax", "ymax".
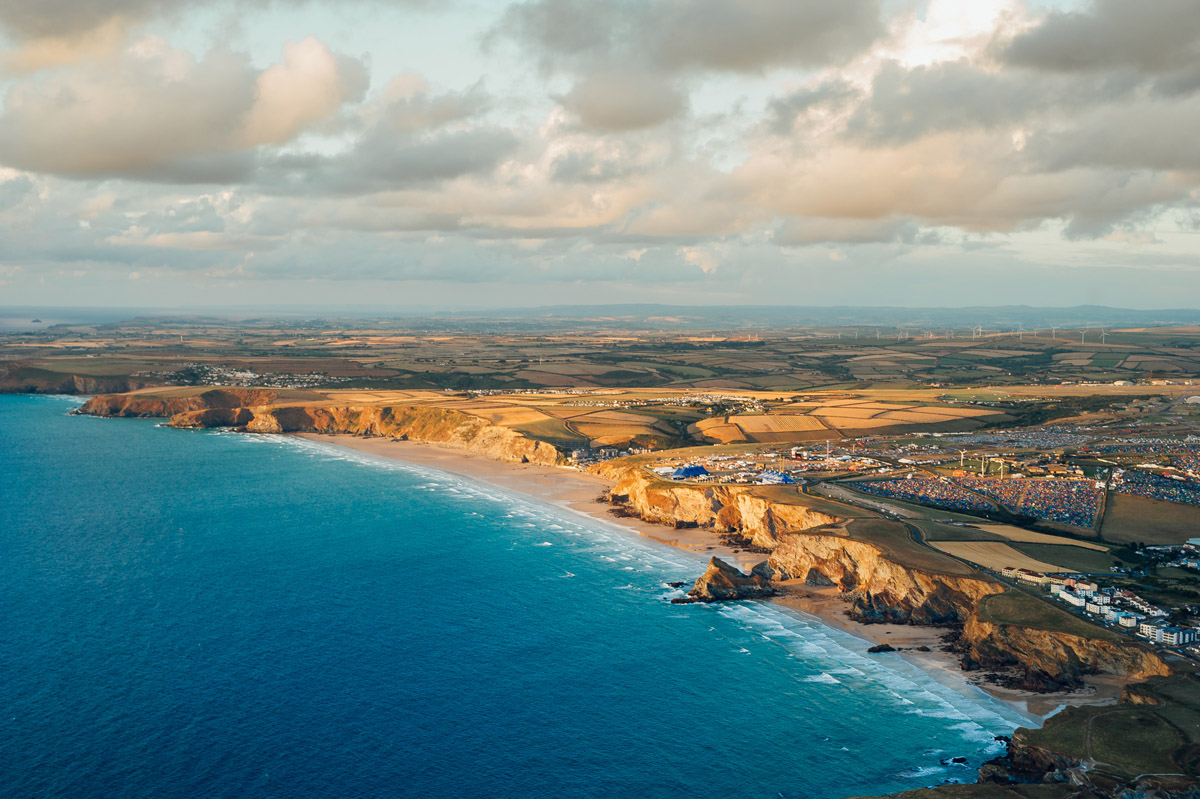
[{"xmin": 488, "ymin": 0, "xmax": 884, "ymax": 131}]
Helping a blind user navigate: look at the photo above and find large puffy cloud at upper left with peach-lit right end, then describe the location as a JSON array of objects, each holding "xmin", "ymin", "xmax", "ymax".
[{"xmin": 0, "ymin": 37, "xmax": 366, "ymax": 182}]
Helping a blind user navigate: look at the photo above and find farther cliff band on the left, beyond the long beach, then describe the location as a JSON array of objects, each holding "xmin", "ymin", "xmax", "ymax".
[{"xmin": 77, "ymin": 389, "xmax": 559, "ymax": 465}]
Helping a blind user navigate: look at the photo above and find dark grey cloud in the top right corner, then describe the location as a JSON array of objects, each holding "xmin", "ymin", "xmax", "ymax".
[{"xmin": 1002, "ymin": 0, "xmax": 1200, "ymax": 73}]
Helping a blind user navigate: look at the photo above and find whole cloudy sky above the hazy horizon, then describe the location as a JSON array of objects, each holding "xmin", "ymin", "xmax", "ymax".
[{"xmin": 0, "ymin": 0, "xmax": 1200, "ymax": 310}]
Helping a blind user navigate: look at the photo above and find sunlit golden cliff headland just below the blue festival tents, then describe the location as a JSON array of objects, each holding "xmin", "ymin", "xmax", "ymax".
[{"xmin": 595, "ymin": 461, "xmax": 840, "ymax": 549}]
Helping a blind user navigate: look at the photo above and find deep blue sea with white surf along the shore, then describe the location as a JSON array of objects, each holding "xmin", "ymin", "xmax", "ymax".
[{"xmin": 0, "ymin": 396, "xmax": 1025, "ymax": 799}]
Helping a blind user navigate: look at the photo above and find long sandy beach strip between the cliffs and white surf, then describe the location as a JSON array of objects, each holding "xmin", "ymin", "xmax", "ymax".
[{"xmin": 294, "ymin": 433, "xmax": 1128, "ymax": 726}]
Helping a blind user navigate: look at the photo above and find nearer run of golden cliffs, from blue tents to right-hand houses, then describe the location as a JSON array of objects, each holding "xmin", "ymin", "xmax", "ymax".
[{"xmin": 595, "ymin": 461, "xmax": 1170, "ymax": 690}]
